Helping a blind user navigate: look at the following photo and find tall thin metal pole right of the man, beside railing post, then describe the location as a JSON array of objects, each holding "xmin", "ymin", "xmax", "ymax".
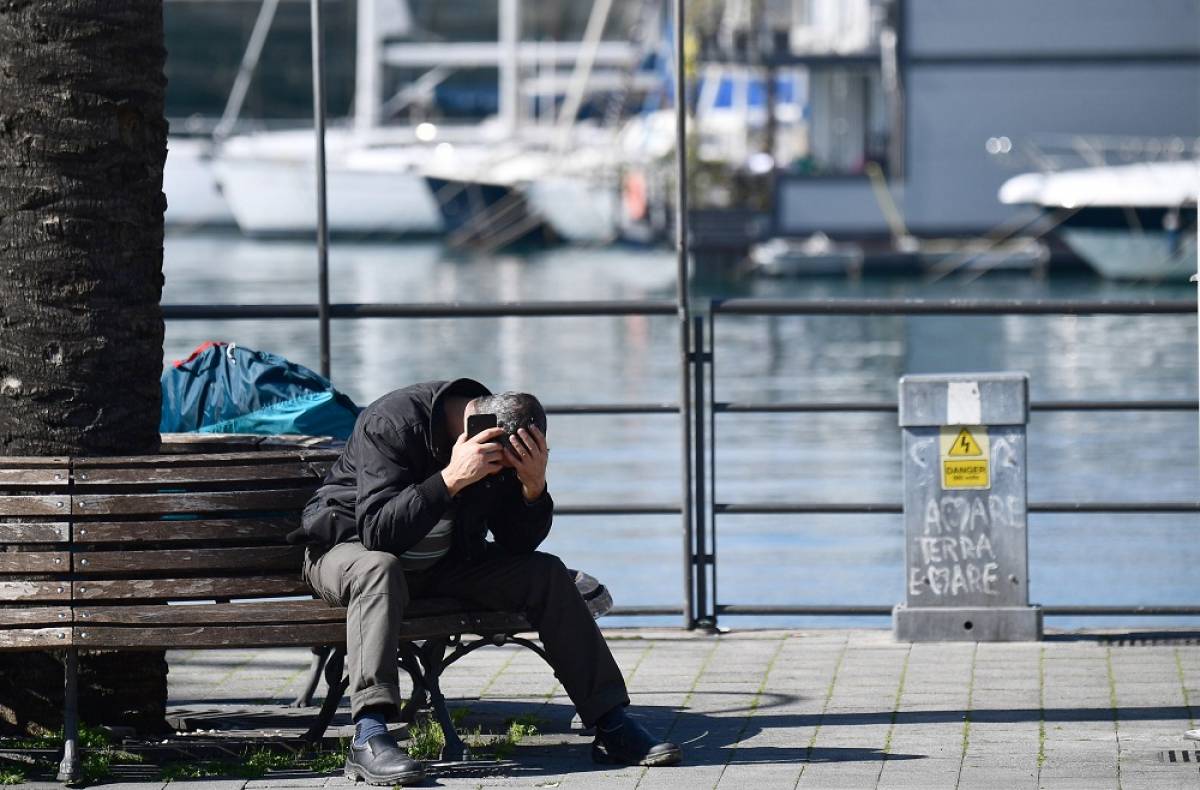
[{"xmin": 674, "ymin": 0, "xmax": 700, "ymax": 628}]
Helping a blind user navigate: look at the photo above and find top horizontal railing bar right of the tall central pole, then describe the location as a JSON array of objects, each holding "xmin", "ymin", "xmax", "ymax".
[{"xmin": 709, "ymin": 299, "xmax": 1196, "ymax": 316}]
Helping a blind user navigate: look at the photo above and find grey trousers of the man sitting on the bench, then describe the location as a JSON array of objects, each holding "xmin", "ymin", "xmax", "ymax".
[{"xmin": 304, "ymin": 543, "xmax": 629, "ymax": 726}]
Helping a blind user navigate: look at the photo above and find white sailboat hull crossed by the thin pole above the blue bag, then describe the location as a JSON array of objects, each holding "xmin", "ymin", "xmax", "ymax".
[{"xmin": 216, "ymin": 157, "xmax": 442, "ymax": 235}]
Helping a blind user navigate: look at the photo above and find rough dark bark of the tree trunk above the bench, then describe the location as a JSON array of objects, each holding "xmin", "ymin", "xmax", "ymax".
[{"xmin": 0, "ymin": 0, "xmax": 167, "ymax": 455}]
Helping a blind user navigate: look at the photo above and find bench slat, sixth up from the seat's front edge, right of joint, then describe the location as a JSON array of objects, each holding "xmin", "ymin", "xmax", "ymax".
[{"xmin": 72, "ymin": 486, "xmax": 313, "ymax": 515}]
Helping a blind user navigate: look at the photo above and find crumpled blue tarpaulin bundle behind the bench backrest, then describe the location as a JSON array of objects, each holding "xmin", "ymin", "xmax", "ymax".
[{"xmin": 158, "ymin": 342, "xmax": 360, "ymax": 439}]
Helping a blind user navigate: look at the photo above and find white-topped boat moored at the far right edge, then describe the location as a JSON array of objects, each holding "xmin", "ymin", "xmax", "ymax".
[{"xmin": 1000, "ymin": 160, "xmax": 1200, "ymax": 281}]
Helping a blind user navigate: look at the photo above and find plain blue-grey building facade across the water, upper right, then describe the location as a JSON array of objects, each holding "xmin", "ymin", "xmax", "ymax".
[{"xmin": 776, "ymin": 0, "xmax": 1200, "ymax": 237}]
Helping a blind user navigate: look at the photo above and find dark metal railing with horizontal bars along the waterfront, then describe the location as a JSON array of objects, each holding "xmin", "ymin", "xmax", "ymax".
[{"xmin": 163, "ymin": 299, "xmax": 1200, "ymax": 627}]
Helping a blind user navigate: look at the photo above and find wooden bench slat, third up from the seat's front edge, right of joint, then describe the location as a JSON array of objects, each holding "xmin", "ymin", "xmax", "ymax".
[{"xmin": 74, "ymin": 571, "xmax": 312, "ymax": 602}]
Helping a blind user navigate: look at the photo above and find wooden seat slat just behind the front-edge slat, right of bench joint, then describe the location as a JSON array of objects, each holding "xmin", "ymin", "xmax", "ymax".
[{"xmin": 75, "ymin": 600, "xmax": 346, "ymax": 626}]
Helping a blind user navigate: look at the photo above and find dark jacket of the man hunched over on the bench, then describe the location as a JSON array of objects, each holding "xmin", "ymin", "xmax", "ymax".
[{"xmin": 288, "ymin": 378, "xmax": 553, "ymax": 561}]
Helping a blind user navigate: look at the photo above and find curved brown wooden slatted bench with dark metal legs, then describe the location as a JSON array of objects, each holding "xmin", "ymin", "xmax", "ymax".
[{"xmin": 0, "ymin": 435, "xmax": 545, "ymax": 782}]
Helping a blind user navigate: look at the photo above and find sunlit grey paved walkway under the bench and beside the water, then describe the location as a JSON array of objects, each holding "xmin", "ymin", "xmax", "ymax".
[{"xmin": 9, "ymin": 629, "xmax": 1200, "ymax": 790}]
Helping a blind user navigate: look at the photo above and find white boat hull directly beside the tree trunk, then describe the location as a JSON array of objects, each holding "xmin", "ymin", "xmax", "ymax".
[{"xmin": 162, "ymin": 137, "xmax": 234, "ymax": 227}]
